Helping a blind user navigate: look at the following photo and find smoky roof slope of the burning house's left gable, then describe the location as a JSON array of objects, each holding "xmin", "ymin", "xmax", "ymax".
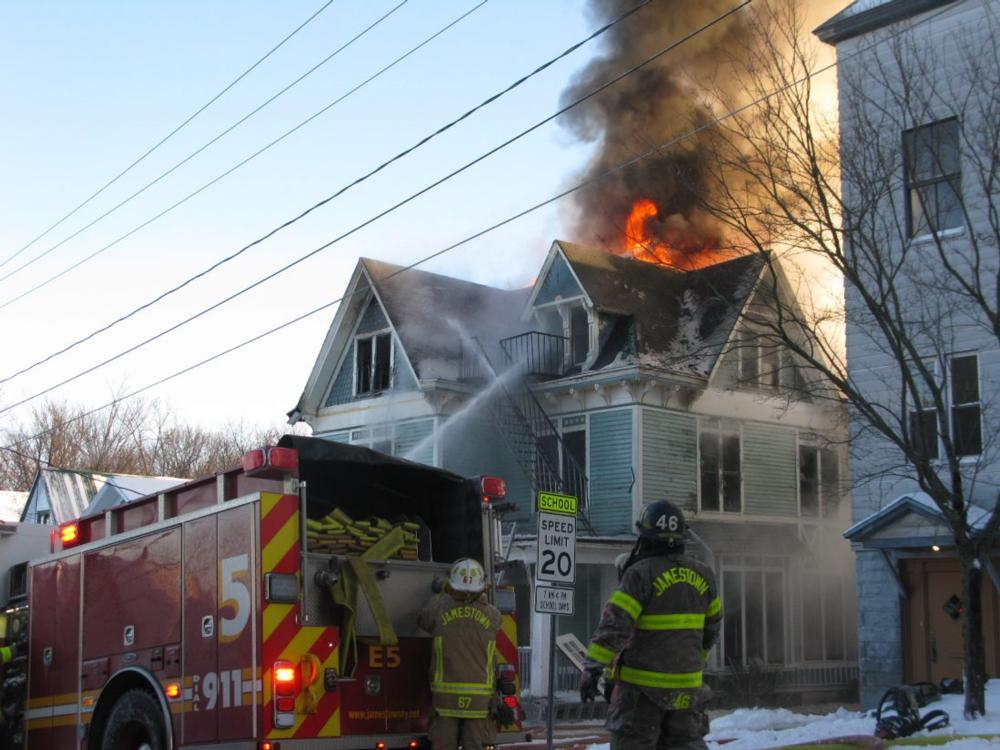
[{"xmin": 361, "ymin": 258, "xmax": 531, "ymax": 380}]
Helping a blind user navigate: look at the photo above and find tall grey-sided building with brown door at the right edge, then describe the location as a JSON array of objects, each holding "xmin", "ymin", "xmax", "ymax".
[{"xmin": 815, "ymin": 0, "xmax": 1000, "ymax": 706}]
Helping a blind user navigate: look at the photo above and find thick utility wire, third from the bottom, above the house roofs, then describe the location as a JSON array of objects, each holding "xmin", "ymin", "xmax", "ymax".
[{"xmin": 0, "ymin": 0, "xmax": 651, "ymax": 385}]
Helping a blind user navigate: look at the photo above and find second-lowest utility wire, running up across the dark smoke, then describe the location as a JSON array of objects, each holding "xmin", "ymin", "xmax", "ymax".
[{"xmin": 0, "ymin": 0, "xmax": 736, "ymax": 414}]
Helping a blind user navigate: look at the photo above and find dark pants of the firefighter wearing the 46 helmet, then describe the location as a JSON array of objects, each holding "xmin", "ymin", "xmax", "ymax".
[{"xmin": 604, "ymin": 683, "xmax": 708, "ymax": 750}]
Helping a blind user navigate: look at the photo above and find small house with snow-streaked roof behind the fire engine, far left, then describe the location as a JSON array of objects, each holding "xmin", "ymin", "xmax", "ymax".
[{"xmin": 20, "ymin": 467, "xmax": 187, "ymax": 526}]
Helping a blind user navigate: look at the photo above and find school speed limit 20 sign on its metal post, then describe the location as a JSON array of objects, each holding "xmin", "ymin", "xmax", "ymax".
[{"xmin": 535, "ymin": 492, "xmax": 578, "ymax": 750}]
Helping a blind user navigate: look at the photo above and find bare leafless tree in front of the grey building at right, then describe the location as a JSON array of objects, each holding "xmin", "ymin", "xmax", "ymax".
[{"xmin": 702, "ymin": 1, "xmax": 1000, "ymax": 717}]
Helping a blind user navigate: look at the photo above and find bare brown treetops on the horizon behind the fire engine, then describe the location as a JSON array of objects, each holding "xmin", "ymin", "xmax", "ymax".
[{"xmin": 0, "ymin": 398, "xmax": 290, "ymax": 490}]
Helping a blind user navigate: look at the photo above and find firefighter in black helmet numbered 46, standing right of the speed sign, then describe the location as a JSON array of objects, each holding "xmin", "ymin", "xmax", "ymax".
[{"xmin": 580, "ymin": 500, "xmax": 722, "ymax": 750}]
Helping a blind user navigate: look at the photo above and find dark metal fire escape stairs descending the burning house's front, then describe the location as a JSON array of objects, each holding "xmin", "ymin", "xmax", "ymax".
[{"xmin": 462, "ymin": 338, "xmax": 596, "ymax": 543}]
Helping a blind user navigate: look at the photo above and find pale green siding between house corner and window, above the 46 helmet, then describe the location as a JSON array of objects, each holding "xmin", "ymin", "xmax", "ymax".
[{"xmin": 642, "ymin": 409, "xmax": 698, "ymax": 510}]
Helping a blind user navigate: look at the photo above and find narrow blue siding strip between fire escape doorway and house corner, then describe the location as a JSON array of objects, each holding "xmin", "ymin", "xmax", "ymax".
[{"xmin": 588, "ymin": 409, "xmax": 634, "ymax": 534}]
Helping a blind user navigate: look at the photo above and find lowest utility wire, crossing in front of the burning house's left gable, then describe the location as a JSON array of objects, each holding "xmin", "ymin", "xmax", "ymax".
[{"xmin": 0, "ymin": 0, "xmax": 947, "ymax": 458}]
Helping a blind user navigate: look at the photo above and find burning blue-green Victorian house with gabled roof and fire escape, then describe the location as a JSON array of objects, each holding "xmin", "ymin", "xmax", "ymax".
[{"xmin": 289, "ymin": 242, "xmax": 856, "ymax": 694}]
